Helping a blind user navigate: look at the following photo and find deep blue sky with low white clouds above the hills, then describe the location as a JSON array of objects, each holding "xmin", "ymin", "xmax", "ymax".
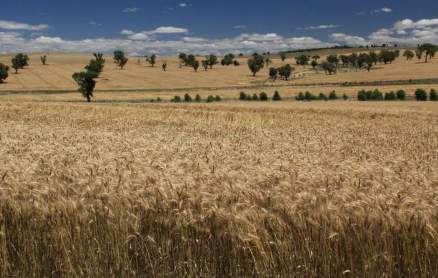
[{"xmin": 0, "ymin": 0, "xmax": 438, "ymax": 54}]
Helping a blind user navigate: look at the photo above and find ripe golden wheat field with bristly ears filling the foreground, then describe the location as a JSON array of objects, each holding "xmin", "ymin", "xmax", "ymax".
[{"xmin": 0, "ymin": 101, "xmax": 438, "ymax": 277}]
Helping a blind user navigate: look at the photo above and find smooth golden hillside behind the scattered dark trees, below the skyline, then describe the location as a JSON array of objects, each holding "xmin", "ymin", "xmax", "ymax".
[{"xmin": 0, "ymin": 50, "xmax": 438, "ymax": 92}]
